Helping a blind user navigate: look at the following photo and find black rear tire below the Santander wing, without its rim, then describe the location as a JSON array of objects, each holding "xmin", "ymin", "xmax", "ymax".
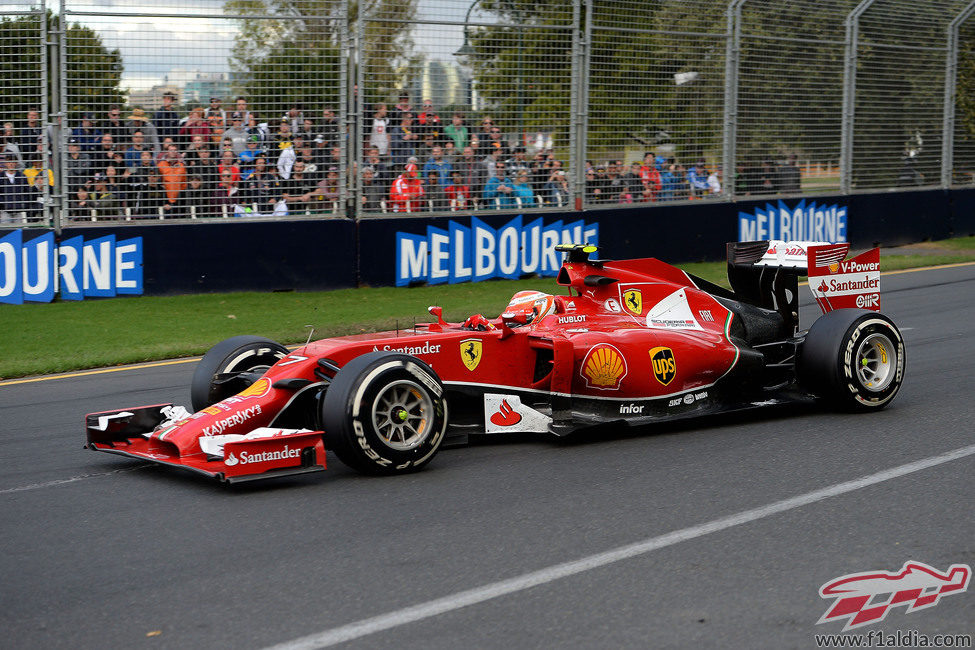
[{"xmin": 798, "ymin": 309, "xmax": 907, "ymax": 411}]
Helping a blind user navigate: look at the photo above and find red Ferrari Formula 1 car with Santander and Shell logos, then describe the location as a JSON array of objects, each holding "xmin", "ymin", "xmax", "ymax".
[{"xmin": 86, "ymin": 242, "xmax": 905, "ymax": 481}]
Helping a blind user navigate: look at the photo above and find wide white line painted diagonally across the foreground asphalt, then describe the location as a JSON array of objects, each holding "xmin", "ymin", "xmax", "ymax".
[{"xmin": 266, "ymin": 445, "xmax": 975, "ymax": 650}]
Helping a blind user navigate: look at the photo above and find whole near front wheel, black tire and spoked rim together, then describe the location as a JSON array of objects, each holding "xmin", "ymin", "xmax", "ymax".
[{"xmin": 321, "ymin": 352, "xmax": 447, "ymax": 475}]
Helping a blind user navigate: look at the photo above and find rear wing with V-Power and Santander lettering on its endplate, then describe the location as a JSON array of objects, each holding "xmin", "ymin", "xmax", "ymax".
[{"xmin": 727, "ymin": 240, "xmax": 880, "ymax": 329}]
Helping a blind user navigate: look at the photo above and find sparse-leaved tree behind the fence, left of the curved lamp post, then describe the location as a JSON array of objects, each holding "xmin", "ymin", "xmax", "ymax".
[{"xmin": 225, "ymin": 0, "xmax": 416, "ymax": 114}]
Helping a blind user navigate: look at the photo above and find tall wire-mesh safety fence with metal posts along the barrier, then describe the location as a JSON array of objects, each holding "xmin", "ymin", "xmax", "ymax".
[{"xmin": 0, "ymin": 0, "xmax": 975, "ymax": 226}]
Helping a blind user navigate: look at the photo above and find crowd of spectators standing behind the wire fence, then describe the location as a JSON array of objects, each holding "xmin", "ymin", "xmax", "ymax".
[{"xmin": 0, "ymin": 93, "xmax": 800, "ymax": 220}]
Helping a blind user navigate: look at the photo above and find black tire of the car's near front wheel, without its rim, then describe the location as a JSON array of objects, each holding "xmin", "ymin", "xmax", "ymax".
[{"xmin": 321, "ymin": 352, "xmax": 448, "ymax": 475}]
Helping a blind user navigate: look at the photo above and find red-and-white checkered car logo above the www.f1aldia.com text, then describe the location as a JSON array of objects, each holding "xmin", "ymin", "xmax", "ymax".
[{"xmin": 816, "ymin": 561, "xmax": 972, "ymax": 632}]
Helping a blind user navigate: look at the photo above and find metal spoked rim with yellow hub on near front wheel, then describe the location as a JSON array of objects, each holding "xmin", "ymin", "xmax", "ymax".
[{"xmin": 372, "ymin": 381, "xmax": 433, "ymax": 451}]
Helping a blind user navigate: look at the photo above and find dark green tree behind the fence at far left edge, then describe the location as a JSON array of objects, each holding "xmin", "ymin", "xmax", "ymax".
[{"xmin": 0, "ymin": 11, "xmax": 125, "ymax": 120}]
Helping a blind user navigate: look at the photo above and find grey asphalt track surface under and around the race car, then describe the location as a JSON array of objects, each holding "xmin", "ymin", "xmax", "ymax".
[{"xmin": 0, "ymin": 265, "xmax": 975, "ymax": 650}]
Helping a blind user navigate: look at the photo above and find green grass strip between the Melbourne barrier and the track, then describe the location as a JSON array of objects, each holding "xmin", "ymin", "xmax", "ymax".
[{"xmin": 0, "ymin": 237, "xmax": 975, "ymax": 379}]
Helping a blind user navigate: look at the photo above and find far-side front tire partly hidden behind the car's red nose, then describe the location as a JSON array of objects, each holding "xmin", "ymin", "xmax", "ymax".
[{"xmin": 190, "ymin": 334, "xmax": 288, "ymax": 411}]
